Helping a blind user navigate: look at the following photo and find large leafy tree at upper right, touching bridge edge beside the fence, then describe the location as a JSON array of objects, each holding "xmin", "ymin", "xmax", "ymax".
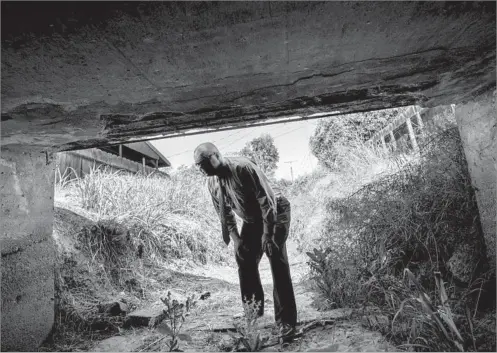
[{"xmin": 309, "ymin": 108, "xmax": 405, "ymax": 168}]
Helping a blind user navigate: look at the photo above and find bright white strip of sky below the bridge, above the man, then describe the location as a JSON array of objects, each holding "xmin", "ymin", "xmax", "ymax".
[{"xmin": 150, "ymin": 119, "xmax": 318, "ymax": 180}]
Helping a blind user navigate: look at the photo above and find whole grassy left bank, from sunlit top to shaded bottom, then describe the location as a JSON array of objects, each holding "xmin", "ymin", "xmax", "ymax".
[{"xmin": 43, "ymin": 164, "xmax": 233, "ymax": 350}]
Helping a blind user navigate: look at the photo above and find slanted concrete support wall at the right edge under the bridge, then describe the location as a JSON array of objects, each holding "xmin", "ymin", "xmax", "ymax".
[{"xmin": 455, "ymin": 91, "xmax": 497, "ymax": 268}]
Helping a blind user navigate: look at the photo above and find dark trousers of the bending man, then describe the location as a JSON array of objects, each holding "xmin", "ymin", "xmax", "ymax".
[{"xmin": 236, "ymin": 195, "xmax": 297, "ymax": 325}]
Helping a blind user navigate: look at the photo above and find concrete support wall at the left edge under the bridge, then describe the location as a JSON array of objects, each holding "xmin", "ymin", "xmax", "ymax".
[{"xmin": 0, "ymin": 146, "xmax": 55, "ymax": 351}]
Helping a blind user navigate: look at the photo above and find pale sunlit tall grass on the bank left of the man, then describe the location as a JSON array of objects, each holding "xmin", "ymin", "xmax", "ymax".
[{"xmin": 56, "ymin": 164, "xmax": 231, "ymax": 263}]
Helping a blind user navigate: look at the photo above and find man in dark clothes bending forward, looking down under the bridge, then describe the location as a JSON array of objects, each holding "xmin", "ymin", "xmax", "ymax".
[{"xmin": 194, "ymin": 143, "xmax": 297, "ymax": 337}]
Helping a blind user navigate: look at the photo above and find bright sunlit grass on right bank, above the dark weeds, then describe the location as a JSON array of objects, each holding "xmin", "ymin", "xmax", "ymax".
[{"xmin": 287, "ymin": 134, "xmax": 415, "ymax": 251}]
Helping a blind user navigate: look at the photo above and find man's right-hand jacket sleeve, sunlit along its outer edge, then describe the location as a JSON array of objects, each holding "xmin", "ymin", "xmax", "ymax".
[{"xmin": 245, "ymin": 165, "xmax": 277, "ymax": 237}]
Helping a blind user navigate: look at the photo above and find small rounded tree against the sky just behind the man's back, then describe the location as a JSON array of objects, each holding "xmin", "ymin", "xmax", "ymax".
[{"xmin": 240, "ymin": 134, "xmax": 280, "ymax": 176}]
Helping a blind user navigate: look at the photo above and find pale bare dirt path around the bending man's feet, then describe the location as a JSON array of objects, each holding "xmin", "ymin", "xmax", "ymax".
[{"xmin": 93, "ymin": 244, "xmax": 395, "ymax": 352}]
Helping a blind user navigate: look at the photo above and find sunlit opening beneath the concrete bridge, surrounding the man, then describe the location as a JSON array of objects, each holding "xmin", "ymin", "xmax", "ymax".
[{"xmin": 45, "ymin": 106, "xmax": 495, "ymax": 351}]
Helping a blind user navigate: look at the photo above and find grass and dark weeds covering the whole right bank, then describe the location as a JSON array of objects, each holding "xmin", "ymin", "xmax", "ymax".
[{"xmin": 297, "ymin": 108, "xmax": 495, "ymax": 351}]
